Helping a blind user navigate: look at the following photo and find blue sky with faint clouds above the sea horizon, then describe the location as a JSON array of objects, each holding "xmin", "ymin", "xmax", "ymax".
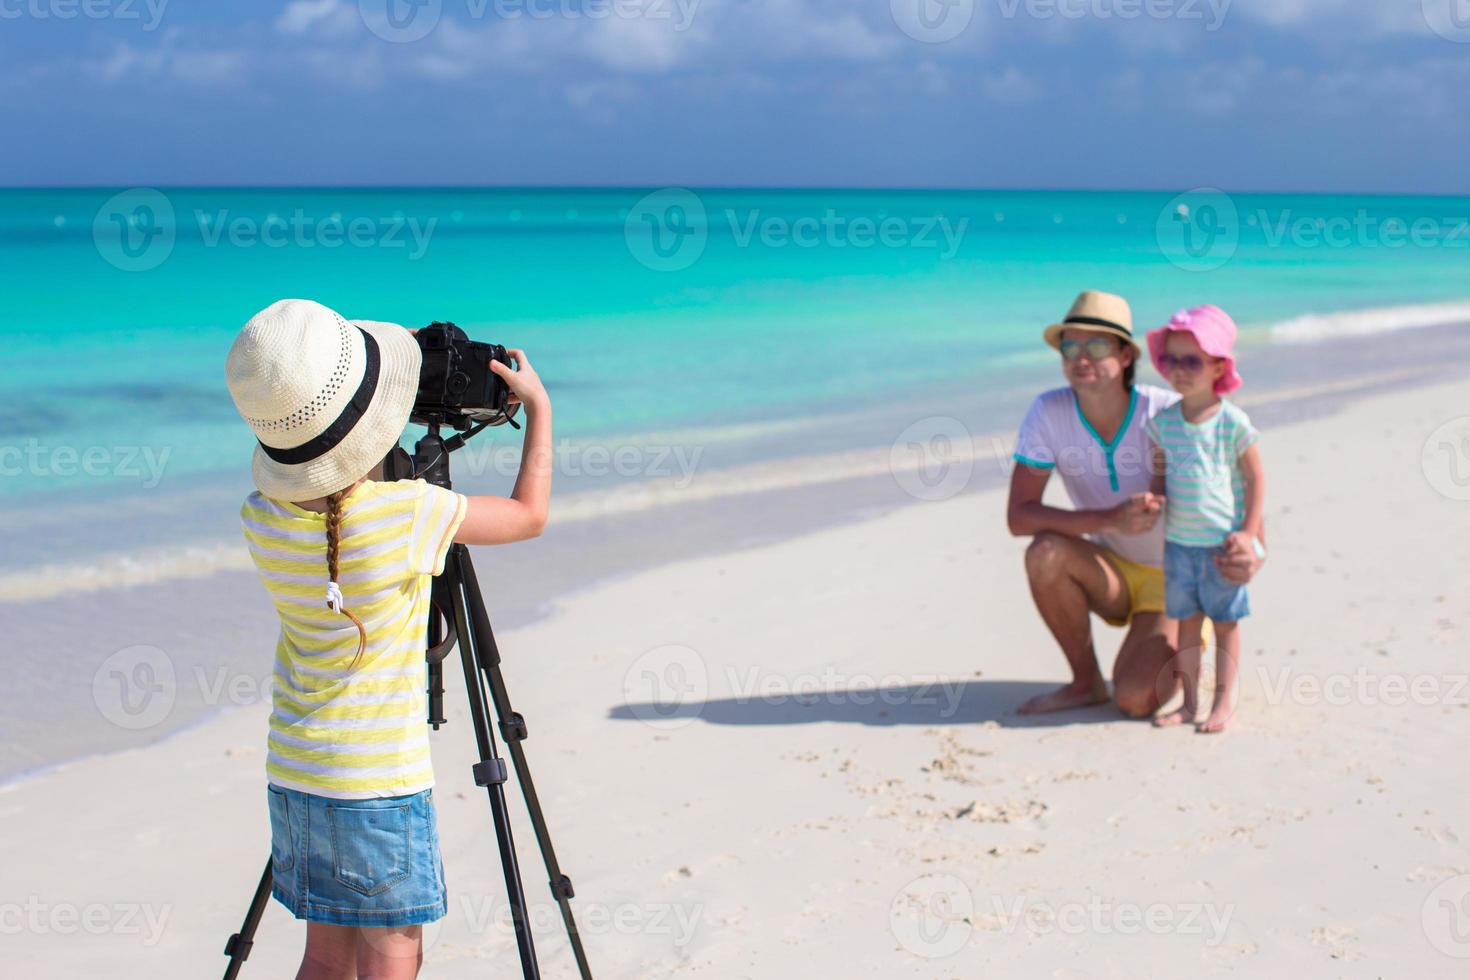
[{"xmin": 0, "ymin": 0, "xmax": 1470, "ymax": 192}]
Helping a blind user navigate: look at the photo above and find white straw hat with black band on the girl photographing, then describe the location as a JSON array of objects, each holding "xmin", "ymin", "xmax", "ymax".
[{"xmin": 225, "ymin": 300, "xmax": 422, "ymax": 502}]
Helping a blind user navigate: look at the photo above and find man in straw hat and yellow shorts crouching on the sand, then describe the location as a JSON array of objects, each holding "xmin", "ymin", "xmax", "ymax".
[{"xmin": 1005, "ymin": 292, "xmax": 1260, "ymax": 718}]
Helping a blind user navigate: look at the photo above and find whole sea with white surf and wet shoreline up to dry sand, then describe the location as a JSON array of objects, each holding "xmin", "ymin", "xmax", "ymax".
[{"xmin": 0, "ymin": 188, "xmax": 1470, "ymax": 780}]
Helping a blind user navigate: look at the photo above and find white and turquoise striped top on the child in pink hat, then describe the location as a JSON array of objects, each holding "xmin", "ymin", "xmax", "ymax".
[{"xmin": 1148, "ymin": 400, "xmax": 1260, "ymax": 548}]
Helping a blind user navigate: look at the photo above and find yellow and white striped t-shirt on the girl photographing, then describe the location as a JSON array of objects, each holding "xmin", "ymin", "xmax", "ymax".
[{"xmin": 240, "ymin": 479, "xmax": 469, "ymax": 799}]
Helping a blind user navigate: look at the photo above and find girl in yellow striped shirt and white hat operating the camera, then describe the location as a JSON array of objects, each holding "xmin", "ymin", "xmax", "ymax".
[{"xmin": 226, "ymin": 300, "xmax": 551, "ymax": 980}]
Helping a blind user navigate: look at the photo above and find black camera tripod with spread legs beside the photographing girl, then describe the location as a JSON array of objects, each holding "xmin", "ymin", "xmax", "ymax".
[{"xmin": 225, "ymin": 419, "xmax": 592, "ymax": 980}]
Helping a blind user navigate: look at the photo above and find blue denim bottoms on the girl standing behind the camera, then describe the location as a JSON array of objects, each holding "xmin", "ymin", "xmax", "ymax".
[{"xmin": 266, "ymin": 783, "xmax": 448, "ymax": 926}]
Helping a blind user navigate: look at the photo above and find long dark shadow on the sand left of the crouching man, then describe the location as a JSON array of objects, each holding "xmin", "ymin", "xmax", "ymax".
[{"xmin": 607, "ymin": 680, "xmax": 1127, "ymax": 729}]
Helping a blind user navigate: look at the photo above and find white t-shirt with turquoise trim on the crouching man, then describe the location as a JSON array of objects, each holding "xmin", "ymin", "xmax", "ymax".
[{"xmin": 1016, "ymin": 385, "xmax": 1179, "ymax": 569}]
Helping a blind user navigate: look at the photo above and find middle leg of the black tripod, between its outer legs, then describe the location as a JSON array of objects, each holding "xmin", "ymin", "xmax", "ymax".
[{"xmin": 444, "ymin": 545, "xmax": 541, "ymax": 980}]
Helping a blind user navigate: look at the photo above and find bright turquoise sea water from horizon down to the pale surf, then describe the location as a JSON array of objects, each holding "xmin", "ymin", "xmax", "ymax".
[{"xmin": 0, "ymin": 188, "xmax": 1470, "ymax": 507}]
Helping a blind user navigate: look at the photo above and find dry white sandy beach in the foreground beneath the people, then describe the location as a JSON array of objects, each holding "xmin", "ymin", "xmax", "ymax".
[{"xmin": 0, "ymin": 371, "xmax": 1470, "ymax": 980}]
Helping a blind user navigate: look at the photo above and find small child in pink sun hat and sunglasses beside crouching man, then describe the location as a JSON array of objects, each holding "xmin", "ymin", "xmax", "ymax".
[{"xmin": 1148, "ymin": 306, "xmax": 1266, "ymax": 732}]
